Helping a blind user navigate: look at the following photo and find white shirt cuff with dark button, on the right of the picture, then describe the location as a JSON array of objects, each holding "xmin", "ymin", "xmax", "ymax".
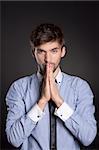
[{"xmin": 54, "ymin": 102, "xmax": 74, "ymax": 121}]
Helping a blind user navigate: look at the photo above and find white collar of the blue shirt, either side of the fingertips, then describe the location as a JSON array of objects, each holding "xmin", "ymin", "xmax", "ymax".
[{"xmin": 37, "ymin": 69, "xmax": 62, "ymax": 85}]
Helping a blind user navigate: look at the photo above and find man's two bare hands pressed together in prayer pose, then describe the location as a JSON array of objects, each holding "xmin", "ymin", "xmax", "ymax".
[{"xmin": 38, "ymin": 64, "xmax": 63, "ymax": 110}]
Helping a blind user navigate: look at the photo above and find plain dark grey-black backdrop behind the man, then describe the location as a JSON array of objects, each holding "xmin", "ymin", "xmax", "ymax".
[{"xmin": 1, "ymin": 1, "xmax": 99, "ymax": 150}]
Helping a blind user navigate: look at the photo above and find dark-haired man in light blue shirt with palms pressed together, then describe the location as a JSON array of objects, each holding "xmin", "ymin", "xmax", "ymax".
[{"xmin": 6, "ymin": 24, "xmax": 96, "ymax": 150}]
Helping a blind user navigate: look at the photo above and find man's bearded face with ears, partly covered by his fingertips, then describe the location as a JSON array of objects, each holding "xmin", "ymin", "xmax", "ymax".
[{"xmin": 34, "ymin": 41, "xmax": 65, "ymax": 74}]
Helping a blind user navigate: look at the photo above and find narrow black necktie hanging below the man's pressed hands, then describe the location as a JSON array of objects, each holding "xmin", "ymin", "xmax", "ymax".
[{"xmin": 49, "ymin": 100, "xmax": 56, "ymax": 150}]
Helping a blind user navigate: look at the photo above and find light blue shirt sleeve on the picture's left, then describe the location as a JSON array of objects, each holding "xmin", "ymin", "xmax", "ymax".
[{"xmin": 5, "ymin": 78, "xmax": 44, "ymax": 147}]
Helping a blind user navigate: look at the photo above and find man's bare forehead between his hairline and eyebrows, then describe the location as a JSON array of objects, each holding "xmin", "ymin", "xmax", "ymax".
[{"xmin": 37, "ymin": 41, "xmax": 61, "ymax": 51}]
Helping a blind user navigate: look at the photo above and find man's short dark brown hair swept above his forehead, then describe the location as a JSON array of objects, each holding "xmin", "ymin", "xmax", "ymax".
[{"xmin": 30, "ymin": 23, "xmax": 64, "ymax": 47}]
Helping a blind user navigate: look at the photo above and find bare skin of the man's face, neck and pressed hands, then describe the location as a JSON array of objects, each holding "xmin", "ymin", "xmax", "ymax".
[{"xmin": 33, "ymin": 41, "xmax": 65, "ymax": 111}]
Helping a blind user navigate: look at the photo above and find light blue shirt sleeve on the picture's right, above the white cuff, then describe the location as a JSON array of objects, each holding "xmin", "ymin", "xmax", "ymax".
[{"xmin": 61, "ymin": 78, "xmax": 97, "ymax": 146}]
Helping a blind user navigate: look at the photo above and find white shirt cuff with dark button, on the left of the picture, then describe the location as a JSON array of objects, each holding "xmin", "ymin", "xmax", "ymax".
[{"xmin": 27, "ymin": 104, "xmax": 45, "ymax": 123}]
